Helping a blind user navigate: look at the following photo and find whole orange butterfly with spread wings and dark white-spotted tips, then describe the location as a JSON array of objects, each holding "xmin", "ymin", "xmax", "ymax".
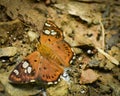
[{"xmin": 9, "ymin": 20, "xmax": 73, "ymax": 84}]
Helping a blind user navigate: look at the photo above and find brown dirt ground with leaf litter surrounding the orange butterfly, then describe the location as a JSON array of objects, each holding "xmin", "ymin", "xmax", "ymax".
[{"xmin": 0, "ymin": 0, "xmax": 120, "ymax": 96}]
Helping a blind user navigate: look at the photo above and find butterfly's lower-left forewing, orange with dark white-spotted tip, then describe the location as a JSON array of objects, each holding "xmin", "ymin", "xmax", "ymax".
[{"xmin": 9, "ymin": 51, "xmax": 40, "ymax": 83}]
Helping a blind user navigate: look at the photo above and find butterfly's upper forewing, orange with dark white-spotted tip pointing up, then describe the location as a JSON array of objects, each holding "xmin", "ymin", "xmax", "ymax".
[{"xmin": 40, "ymin": 20, "xmax": 63, "ymax": 45}]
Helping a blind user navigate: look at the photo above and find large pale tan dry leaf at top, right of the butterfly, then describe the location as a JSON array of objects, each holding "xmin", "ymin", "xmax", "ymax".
[{"xmin": 55, "ymin": 2, "xmax": 101, "ymax": 23}]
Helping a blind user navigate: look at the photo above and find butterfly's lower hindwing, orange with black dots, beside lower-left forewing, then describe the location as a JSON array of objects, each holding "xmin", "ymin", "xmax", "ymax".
[{"xmin": 39, "ymin": 58, "xmax": 64, "ymax": 82}]
